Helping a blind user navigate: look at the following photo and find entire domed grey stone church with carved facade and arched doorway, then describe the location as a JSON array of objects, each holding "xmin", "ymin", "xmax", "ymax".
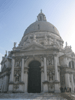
[{"xmin": 0, "ymin": 11, "xmax": 75, "ymax": 93}]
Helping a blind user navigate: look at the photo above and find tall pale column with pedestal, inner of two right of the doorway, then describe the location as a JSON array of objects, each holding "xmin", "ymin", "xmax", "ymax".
[{"xmin": 43, "ymin": 57, "xmax": 48, "ymax": 92}]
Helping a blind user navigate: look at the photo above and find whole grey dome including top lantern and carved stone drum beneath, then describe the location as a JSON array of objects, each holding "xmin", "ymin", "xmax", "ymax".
[{"xmin": 19, "ymin": 12, "xmax": 63, "ymax": 48}]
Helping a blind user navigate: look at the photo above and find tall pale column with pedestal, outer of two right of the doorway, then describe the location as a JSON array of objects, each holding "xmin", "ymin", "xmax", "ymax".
[{"xmin": 54, "ymin": 55, "xmax": 60, "ymax": 93}]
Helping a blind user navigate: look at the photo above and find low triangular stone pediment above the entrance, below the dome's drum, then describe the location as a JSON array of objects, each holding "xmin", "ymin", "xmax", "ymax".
[{"xmin": 22, "ymin": 43, "xmax": 45, "ymax": 50}]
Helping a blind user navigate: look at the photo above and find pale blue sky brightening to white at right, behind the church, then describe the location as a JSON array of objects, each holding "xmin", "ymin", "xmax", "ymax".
[{"xmin": 0, "ymin": 0, "xmax": 75, "ymax": 70}]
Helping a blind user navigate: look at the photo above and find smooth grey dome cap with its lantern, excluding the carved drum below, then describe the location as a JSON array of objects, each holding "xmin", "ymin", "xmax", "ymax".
[{"xmin": 24, "ymin": 12, "xmax": 59, "ymax": 35}]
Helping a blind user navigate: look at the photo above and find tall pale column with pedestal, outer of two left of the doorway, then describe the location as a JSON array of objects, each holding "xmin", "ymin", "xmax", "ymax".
[{"xmin": 9, "ymin": 58, "xmax": 15, "ymax": 92}]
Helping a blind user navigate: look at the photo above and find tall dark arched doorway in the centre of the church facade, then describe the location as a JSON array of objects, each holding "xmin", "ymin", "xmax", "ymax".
[{"xmin": 28, "ymin": 60, "xmax": 41, "ymax": 93}]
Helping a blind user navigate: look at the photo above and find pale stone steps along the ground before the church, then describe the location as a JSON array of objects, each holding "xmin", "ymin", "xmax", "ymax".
[{"xmin": 0, "ymin": 93, "xmax": 75, "ymax": 100}]
